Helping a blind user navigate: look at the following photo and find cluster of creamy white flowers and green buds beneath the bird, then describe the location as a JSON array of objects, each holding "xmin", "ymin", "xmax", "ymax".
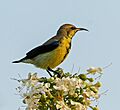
[{"xmin": 17, "ymin": 67, "xmax": 102, "ymax": 110}]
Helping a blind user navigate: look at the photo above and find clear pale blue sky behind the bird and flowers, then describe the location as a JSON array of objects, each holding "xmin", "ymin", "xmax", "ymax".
[{"xmin": 0, "ymin": 0, "xmax": 120, "ymax": 110}]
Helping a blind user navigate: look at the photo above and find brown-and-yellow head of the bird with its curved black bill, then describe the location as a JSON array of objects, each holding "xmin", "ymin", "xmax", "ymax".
[{"xmin": 57, "ymin": 24, "xmax": 88, "ymax": 38}]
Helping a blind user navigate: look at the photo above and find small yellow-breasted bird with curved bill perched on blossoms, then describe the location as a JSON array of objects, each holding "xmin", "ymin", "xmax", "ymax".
[{"xmin": 12, "ymin": 24, "xmax": 88, "ymax": 72}]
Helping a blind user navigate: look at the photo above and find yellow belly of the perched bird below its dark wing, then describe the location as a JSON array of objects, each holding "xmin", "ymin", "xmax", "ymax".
[{"xmin": 33, "ymin": 47, "xmax": 68, "ymax": 69}]
